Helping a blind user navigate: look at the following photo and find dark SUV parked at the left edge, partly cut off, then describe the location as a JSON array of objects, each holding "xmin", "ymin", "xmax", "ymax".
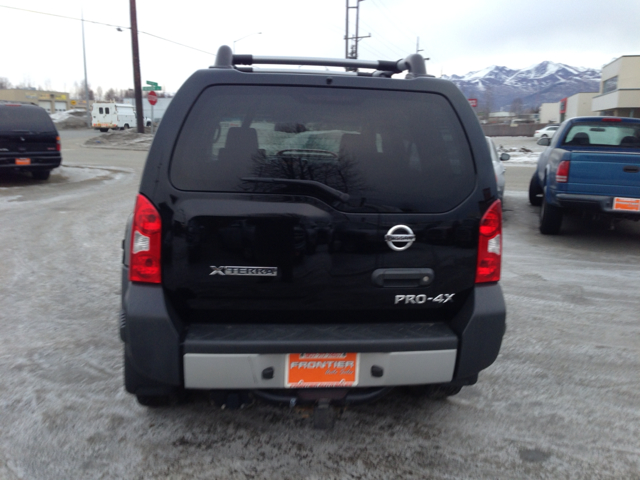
[{"xmin": 0, "ymin": 102, "xmax": 62, "ymax": 180}]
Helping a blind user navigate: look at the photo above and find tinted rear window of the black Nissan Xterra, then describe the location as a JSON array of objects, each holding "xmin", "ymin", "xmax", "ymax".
[{"xmin": 170, "ymin": 86, "xmax": 475, "ymax": 213}]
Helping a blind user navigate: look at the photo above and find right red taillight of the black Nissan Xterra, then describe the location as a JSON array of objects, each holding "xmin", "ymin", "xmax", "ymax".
[{"xmin": 476, "ymin": 200, "xmax": 502, "ymax": 283}]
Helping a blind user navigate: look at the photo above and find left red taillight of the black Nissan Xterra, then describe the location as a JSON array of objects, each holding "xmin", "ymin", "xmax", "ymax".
[{"xmin": 129, "ymin": 195, "xmax": 162, "ymax": 283}]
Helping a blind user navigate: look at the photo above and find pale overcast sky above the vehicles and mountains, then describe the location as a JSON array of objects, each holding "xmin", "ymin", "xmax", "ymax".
[{"xmin": 0, "ymin": 0, "xmax": 640, "ymax": 92}]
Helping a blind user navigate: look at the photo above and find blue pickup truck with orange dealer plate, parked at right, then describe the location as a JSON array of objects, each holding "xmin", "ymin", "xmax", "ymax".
[{"xmin": 529, "ymin": 117, "xmax": 640, "ymax": 235}]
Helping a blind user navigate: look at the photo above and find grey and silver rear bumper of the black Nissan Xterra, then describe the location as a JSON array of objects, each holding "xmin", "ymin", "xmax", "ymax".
[{"xmin": 120, "ymin": 276, "xmax": 506, "ymax": 393}]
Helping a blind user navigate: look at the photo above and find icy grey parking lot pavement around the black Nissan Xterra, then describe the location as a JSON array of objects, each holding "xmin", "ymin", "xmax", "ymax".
[{"xmin": 0, "ymin": 137, "xmax": 640, "ymax": 480}]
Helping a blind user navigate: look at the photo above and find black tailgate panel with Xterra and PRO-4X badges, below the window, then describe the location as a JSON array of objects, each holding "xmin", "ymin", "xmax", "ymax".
[{"xmin": 163, "ymin": 196, "xmax": 477, "ymax": 323}]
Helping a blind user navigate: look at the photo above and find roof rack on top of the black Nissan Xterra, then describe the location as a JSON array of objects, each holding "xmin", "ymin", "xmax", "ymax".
[{"xmin": 211, "ymin": 45, "xmax": 432, "ymax": 78}]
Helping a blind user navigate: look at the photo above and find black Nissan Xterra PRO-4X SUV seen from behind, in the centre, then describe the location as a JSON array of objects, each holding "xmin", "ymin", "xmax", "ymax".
[{"xmin": 120, "ymin": 46, "xmax": 505, "ymax": 416}]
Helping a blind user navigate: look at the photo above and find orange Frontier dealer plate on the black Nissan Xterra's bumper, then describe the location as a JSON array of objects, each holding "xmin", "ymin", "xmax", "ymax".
[{"xmin": 285, "ymin": 353, "xmax": 360, "ymax": 388}]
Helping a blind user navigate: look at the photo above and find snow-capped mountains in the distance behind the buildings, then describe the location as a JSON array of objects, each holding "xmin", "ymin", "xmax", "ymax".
[{"xmin": 442, "ymin": 62, "xmax": 600, "ymax": 111}]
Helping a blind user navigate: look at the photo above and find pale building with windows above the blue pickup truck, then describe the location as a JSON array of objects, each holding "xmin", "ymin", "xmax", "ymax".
[{"xmin": 591, "ymin": 55, "xmax": 640, "ymax": 118}]
